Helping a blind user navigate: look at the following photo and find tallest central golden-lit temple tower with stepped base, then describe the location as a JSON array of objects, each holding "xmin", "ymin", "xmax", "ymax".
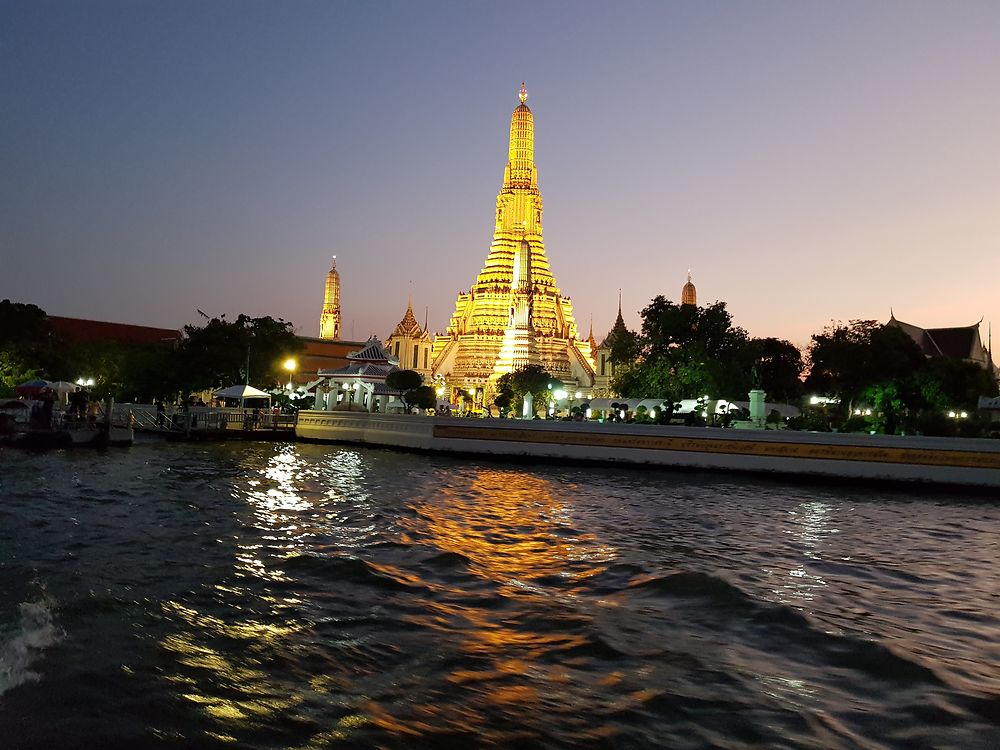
[{"xmin": 433, "ymin": 83, "xmax": 594, "ymax": 389}]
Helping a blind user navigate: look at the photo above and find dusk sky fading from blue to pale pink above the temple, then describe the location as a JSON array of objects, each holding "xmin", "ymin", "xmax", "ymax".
[{"xmin": 0, "ymin": 0, "xmax": 1000, "ymax": 345}]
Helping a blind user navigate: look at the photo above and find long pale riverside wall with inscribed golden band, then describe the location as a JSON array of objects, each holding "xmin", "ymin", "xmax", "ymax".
[{"xmin": 295, "ymin": 411, "xmax": 1000, "ymax": 498}]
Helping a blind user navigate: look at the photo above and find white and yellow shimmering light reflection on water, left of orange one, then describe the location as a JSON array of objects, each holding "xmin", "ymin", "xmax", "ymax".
[{"xmin": 160, "ymin": 445, "xmax": 378, "ymax": 743}]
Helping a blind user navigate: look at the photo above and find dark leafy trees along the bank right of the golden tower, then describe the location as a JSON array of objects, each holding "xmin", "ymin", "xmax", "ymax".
[{"xmin": 611, "ymin": 296, "xmax": 997, "ymax": 435}]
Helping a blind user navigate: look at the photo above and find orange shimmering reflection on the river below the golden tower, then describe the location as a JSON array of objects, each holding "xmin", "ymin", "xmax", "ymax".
[{"xmin": 386, "ymin": 468, "xmax": 616, "ymax": 736}]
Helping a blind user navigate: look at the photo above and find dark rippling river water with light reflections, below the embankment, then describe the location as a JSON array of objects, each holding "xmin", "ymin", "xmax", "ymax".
[{"xmin": 0, "ymin": 443, "xmax": 1000, "ymax": 750}]
